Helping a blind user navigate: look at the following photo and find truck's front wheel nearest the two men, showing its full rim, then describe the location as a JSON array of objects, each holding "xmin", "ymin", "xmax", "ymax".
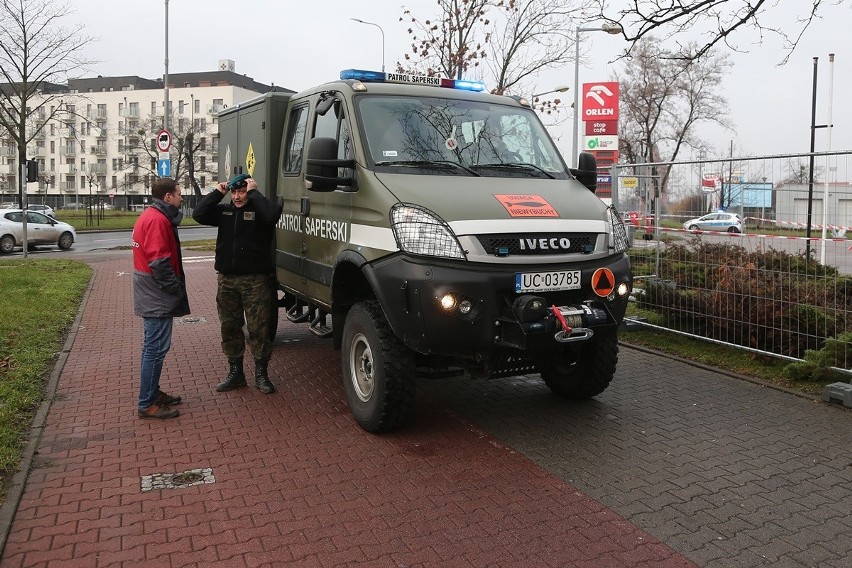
[{"xmin": 341, "ymin": 301, "xmax": 416, "ymax": 433}]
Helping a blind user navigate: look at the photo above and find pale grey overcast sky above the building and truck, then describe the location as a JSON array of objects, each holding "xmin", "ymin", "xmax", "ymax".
[{"xmin": 68, "ymin": 0, "xmax": 852, "ymax": 159}]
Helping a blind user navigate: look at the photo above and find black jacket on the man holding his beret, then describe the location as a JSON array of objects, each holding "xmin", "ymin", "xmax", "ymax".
[{"xmin": 192, "ymin": 189, "xmax": 283, "ymax": 274}]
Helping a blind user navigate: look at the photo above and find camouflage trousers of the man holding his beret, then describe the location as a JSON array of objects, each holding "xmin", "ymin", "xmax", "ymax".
[{"xmin": 216, "ymin": 274, "xmax": 278, "ymax": 361}]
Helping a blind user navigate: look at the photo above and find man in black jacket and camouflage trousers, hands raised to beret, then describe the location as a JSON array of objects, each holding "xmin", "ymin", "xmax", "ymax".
[{"xmin": 192, "ymin": 174, "xmax": 282, "ymax": 394}]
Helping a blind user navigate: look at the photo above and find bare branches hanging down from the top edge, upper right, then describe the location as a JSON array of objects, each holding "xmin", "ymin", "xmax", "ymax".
[{"xmin": 594, "ymin": 0, "xmax": 832, "ymax": 63}]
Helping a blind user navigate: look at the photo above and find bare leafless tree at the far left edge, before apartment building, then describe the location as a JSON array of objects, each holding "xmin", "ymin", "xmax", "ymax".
[{"xmin": 0, "ymin": 0, "xmax": 93, "ymax": 206}]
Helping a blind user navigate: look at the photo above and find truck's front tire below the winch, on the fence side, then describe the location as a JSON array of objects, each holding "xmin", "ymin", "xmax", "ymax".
[{"xmin": 541, "ymin": 337, "xmax": 618, "ymax": 400}]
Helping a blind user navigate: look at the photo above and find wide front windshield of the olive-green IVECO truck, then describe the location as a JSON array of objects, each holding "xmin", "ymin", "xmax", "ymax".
[{"xmin": 357, "ymin": 95, "xmax": 570, "ymax": 179}]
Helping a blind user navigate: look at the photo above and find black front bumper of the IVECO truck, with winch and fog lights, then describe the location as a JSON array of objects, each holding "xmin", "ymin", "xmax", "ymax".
[{"xmin": 365, "ymin": 254, "xmax": 631, "ymax": 356}]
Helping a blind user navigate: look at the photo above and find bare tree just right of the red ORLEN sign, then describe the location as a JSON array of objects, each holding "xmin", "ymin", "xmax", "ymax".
[{"xmin": 619, "ymin": 38, "xmax": 729, "ymax": 211}]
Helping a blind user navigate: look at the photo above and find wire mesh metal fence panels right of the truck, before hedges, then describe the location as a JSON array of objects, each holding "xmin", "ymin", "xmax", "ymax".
[{"xmin": 612, "ymin": 151, "xmax": 852, "ymax": 374}]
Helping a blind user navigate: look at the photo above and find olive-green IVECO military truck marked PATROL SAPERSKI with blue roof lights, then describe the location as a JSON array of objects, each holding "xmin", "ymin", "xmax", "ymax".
[{"xmin": 219, "ymin": 69, "xmax": 632, "ymax": 432}]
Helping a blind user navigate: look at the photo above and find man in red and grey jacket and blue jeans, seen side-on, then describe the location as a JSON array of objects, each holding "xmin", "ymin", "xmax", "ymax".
[{"xmin": 131, "ymin": 178, "xmax": 189, "ymax": 418}]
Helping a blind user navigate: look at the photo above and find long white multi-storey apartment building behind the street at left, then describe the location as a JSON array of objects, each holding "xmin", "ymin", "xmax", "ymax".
[{"xmin": 0, "ymin": 60, "xmax": 292, "ymax": 208}]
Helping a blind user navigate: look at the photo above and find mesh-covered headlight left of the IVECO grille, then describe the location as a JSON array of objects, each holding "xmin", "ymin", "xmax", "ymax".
[{"xmin": 391, "ymin": 203, "xmax": 465, "ymax": 259}]
